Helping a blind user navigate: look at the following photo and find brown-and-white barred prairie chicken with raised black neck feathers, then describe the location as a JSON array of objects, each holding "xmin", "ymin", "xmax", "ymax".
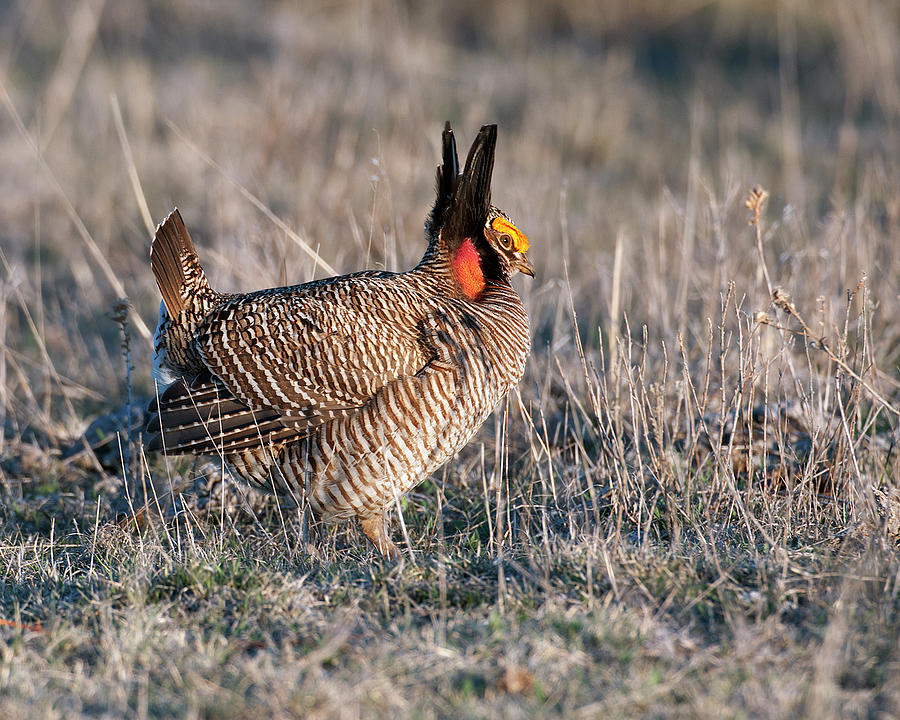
[{"xmin": 148, "ymin": 123, "xmax": 534, "ymax": 556}]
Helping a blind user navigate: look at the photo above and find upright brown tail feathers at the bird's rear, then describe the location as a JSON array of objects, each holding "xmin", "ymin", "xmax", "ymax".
[{"xmin": 150, "ymin": 208, "xmax": 210, "ymax": 318}]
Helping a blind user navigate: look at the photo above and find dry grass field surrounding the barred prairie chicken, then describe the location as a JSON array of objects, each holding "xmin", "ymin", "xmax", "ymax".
[{"xmin": 0, "ymin": 0, "xmax": 900, "ymax": 719}]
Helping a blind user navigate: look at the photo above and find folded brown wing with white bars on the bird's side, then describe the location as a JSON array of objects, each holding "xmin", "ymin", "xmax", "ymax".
[{"xmin": 149, "ymin": 274, "xmax": 429, "ymax": 453}]
